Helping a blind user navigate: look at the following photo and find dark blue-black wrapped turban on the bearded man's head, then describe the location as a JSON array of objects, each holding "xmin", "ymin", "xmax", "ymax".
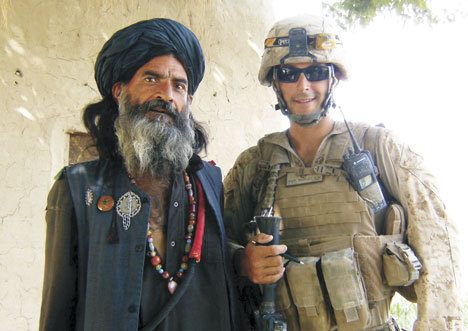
[{"xmin": 94, "ymin": 18, "xmax": 205, "ymax": 97}]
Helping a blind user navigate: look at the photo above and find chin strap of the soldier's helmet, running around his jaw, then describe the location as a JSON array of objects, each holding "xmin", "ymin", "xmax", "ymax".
[{"xmin": 273, "ymin": 64, "xmax": 338, "ymax": 126}]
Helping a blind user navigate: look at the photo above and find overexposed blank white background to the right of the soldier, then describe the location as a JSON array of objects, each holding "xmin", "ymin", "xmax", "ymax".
[{"xmin": 274, "ymin": 0, "xmax": 468, "ymax": 297}]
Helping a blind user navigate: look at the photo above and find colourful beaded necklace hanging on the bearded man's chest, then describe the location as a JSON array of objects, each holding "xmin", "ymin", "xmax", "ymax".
[{"xmin": 146, "ymin": 171, "xmax": 197, "ymax": 294}]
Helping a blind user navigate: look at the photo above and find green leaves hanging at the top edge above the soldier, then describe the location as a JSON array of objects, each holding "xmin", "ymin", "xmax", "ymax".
[{"xmin": 323, "ymin": 0, "xmax": 437, "ymax": 27}]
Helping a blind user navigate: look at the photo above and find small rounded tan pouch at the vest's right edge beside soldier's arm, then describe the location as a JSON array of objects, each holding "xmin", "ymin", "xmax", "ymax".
[{"xmin": 383, "ymin": 242, "xmax": 422, "ymax": 286}]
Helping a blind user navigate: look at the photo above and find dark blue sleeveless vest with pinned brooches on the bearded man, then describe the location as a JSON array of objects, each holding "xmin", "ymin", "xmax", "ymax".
[{"xmin": 65, "ymin": 161, "xmax": 237, "ymax": 330}]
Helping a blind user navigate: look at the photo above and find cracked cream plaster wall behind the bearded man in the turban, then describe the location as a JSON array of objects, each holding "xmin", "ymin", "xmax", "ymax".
[{"xmin": 0, "ymin": 0, "xmax": 282, "ymax": 330}]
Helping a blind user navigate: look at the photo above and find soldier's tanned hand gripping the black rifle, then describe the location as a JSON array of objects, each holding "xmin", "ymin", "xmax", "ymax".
[{"xmin": 240, "ymin": 233, "xmax": 288, "ymax": 284}]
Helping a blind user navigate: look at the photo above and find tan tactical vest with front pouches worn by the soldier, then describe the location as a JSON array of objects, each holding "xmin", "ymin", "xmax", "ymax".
[{"xmin": 252, "ymin": 127, "xmax": 416, "ymax": 331}]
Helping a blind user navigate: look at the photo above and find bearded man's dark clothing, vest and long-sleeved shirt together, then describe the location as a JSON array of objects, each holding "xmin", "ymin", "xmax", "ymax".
[{"xmin": 40, "ymin": 156, "xmax": 239, "ymax": 331}]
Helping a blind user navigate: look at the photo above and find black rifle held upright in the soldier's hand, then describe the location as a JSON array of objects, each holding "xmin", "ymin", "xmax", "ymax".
[{"xmin": 253, "ymin": 216, "xmax": 287, "ymax": 331}]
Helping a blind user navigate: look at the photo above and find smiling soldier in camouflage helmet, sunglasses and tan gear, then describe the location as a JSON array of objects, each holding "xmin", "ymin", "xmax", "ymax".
[{"xmin": 224, "ymin": 15, "xmax": 461, "ymax": 330}]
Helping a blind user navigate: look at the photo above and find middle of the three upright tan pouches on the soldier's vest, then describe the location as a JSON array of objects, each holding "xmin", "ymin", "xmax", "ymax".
[{"xmin": 322, "ymin": 248, "xmax": 370, "ymax": 331}]
